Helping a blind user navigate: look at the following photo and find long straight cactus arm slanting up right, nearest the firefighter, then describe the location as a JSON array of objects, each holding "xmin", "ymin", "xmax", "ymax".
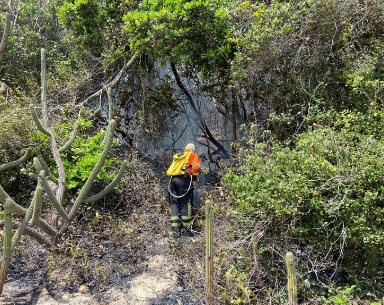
[{"xmin": 68, "ymin": 120, "xmax": 115, "ymax": 220}]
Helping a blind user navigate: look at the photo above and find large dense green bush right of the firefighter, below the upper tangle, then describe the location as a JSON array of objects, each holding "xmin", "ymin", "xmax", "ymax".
[{"xmin": 223, "ymin": 109, "xmax": 384, "ymax": 286}]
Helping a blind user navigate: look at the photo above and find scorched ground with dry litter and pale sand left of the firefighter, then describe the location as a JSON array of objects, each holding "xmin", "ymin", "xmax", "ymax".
[{"xmin": 0, "ymin": 167, "xmax": 210, "ymax": 305}]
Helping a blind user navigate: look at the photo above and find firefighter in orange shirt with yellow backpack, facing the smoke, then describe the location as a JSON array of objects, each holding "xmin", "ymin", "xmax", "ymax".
[{"xmin": 167, "ymin": 143, "xmax": 201, "ymax": 237}]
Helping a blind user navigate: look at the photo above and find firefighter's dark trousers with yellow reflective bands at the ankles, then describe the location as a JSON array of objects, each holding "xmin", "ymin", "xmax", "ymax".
[{"xmin": 170, "ymin": 175, "xmax": 193, "ymax": 230}]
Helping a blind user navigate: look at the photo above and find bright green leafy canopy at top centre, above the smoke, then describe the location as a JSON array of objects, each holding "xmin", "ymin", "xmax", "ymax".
[{"xmin": 124, "ymin": 0, "xmax": 234, "ymax": 74}]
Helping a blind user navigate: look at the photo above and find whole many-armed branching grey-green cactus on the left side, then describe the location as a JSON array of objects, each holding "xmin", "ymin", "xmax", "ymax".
[{"xmin": 0, "ymin": 49, "xmax": 127, "ymax": 294}]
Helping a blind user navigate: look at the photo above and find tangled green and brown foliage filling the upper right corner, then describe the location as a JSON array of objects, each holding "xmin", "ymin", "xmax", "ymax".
[{"xmin": 231, "ymin": 0, "xmax": 384, "ymax": 138}]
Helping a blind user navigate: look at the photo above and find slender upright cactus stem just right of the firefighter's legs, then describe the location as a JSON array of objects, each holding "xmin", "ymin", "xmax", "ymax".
[{"xmin": 205, "ymin": 200, "xmax": 213, "ymax": 305}]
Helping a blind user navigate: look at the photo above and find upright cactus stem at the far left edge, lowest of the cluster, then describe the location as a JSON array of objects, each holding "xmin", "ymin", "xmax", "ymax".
[{"xmin": 0, "ymin": 199, "xmax": 13, "ymax": 294}]
